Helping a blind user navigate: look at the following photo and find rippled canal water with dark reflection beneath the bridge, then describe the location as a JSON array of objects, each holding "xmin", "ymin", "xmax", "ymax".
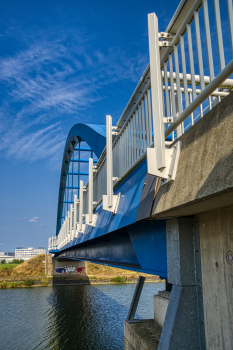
[{"xmin": 0, "ymin": 283, "xmax": 165, "ymax": 350}]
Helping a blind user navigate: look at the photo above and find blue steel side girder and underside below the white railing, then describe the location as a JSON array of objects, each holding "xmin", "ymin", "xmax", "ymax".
[{"xmin": 54, "ymin": 154, "xmax": 167, "ymax": 277}]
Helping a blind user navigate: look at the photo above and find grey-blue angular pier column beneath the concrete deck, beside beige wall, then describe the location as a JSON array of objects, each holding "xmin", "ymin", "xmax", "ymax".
[{"xmin": 158, "ymin": 217, "xmax": 205, "ymax": 350}]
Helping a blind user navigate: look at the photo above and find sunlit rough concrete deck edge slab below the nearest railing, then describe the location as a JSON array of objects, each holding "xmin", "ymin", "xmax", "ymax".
[{"xmin": 152, "ymin": 93, "xmax": 233, "ymax": 218}]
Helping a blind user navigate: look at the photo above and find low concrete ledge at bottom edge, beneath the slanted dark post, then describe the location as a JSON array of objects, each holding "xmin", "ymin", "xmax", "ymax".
[{"xmin": 124, "ymin": 320, "xmax": 161, "ymax": 350}]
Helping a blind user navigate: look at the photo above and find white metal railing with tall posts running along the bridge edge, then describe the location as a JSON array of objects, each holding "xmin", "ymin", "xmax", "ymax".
[{"xmin": 49, "ymin": 0, "xmax": 233, "ymax": 249}]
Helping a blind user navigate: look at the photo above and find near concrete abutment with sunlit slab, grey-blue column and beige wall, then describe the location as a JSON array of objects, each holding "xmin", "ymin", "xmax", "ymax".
[{"xmin": 125, "ymin": 94, "xmax": 233, "ymax": 350}]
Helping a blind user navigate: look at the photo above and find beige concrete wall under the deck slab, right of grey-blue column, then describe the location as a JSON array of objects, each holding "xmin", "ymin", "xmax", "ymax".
[{"xmin": 199, "ymin": 206, "xmax": 233, "ymax": 350}]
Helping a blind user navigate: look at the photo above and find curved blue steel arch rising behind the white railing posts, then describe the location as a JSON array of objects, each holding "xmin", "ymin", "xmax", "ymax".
[{"xmin": 56, "ymin": 123, "xmax": 106, "ymax": 234}]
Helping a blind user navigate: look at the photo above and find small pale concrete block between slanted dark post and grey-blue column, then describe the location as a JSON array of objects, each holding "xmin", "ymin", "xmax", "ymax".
[{"xmin": 153, "ymin": 291, "xmax": 170, "ymax": 328}]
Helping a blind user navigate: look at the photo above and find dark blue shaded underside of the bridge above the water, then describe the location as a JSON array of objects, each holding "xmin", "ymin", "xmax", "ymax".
[{"xmin": 55, "ymin": 220, "xmax": 167, "ymax": 277}]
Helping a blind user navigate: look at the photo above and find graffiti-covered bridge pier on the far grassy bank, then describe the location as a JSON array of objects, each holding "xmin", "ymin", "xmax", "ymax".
[{"xmin": 52, "ymin": 257, "xmax": 89, "ymax": 285}]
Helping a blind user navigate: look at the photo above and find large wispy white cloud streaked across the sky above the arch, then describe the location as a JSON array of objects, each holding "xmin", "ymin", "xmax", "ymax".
[{"xmin": 0, "ymin": 28, "xmax": 148, "ymax": 167}]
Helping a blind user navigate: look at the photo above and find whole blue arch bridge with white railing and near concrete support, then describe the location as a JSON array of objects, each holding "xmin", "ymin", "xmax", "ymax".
[{"xmin": 49, "ymin": 0, "xmax": 233, "ymax": 350}]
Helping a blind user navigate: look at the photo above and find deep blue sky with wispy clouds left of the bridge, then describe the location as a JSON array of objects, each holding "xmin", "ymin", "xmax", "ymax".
[{"xmin": 0, "ymin": 0, "xmax": 179, "ymax": 251}]
